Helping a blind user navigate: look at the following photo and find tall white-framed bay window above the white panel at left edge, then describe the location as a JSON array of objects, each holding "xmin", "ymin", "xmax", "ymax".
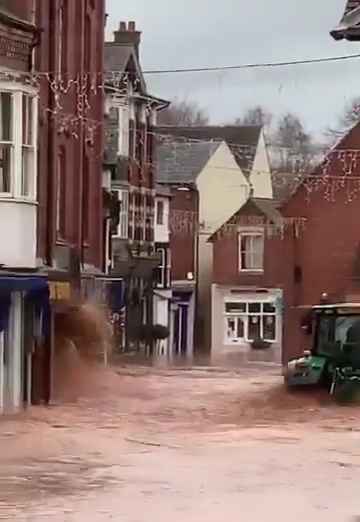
[{"xmin": 0, "ymin": 86, "xmax": 37, "ymax": 200}]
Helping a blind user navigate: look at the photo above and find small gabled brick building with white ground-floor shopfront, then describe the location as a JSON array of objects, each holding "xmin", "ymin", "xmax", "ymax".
[{"xmin": 210, "ymin": 198, "xmax": 284, "ymax": 363}]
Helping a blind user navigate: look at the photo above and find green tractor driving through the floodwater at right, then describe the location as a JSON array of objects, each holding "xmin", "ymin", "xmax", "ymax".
[{"xmin": 285, "ymin": 303, "xmax": 360, "ymax": 402}]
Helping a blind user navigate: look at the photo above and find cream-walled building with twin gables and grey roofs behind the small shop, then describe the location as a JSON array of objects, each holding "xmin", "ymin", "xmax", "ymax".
[{"xmin": 157, "ymin": 126, "xmax": 272, "ymax": 352}]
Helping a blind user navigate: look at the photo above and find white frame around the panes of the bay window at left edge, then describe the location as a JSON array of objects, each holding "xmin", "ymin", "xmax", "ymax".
[{"xmin": 0, "ymin": 82, "xmax": 38, "ymax": 202}]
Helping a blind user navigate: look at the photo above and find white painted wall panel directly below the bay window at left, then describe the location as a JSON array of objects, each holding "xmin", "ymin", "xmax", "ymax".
[{"xmin": 0, "ymin": 198, "xmax": 37, "ymax": 268}]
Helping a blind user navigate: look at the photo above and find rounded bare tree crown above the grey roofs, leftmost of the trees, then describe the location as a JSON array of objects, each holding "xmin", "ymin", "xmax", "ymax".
[{"xmin": 159, "ymin": 99, "xmax": 209, "ymax": 127}]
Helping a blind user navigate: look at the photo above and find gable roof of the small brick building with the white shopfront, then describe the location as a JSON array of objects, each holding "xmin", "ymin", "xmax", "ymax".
[{"xmin": 208, "ymin": 197, "xmax": 283, "ymax": 243}]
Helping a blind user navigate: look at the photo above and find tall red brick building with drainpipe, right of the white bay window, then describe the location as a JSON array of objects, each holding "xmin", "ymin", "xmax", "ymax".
[{"xmin": 36, "ymin": 0, "xmax": 105, "ymax": 289}]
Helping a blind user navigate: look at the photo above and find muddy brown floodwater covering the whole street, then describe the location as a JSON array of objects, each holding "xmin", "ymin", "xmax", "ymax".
[{"xmin": 0, "ymin": 367, "xmax": 360, "ymax": 522}]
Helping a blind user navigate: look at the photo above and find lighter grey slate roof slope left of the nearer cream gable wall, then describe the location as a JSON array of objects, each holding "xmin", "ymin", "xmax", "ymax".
[{"xmin": 155, "ymin": 141, "xmax": 220, "ymax": 184}]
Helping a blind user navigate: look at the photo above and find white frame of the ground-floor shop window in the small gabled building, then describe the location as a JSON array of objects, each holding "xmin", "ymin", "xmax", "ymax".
[{"xmin": 224, "ymin": 299, "xmax": 280, "ymax": 345}]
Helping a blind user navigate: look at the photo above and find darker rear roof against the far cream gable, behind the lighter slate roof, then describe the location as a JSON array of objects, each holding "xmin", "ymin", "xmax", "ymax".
[{"xmin": 155, "ymin": 125, "xmax": 262, "ymax": 176}]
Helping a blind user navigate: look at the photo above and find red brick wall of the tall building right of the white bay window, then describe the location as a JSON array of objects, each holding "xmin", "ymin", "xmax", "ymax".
[{"xmin": 36, "ymin": 0, "xmax": 105, "ymax": 268}]
